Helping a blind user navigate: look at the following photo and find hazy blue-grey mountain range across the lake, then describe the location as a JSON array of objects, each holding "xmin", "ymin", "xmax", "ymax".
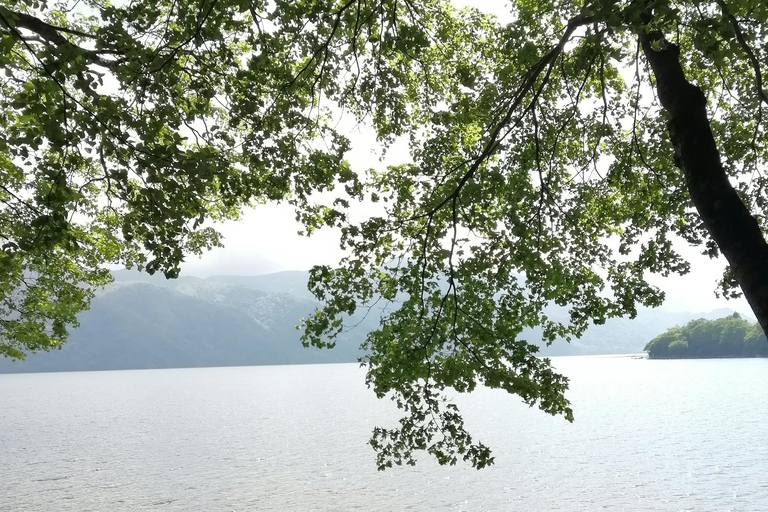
[{"xmin": 0, "ymin": 270, "xmax": 748, "ymax": 373}]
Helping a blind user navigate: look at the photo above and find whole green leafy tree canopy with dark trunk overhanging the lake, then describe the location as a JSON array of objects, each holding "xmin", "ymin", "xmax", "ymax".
[{"xmin": 0, "ymin": 0, "xmax": 768, "ymax": 468}]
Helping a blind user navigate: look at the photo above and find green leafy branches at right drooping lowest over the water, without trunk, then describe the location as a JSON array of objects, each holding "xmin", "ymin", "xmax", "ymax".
[{"xmin": 304, "ymin": 0, "xmax": 768, "ymax": 469}]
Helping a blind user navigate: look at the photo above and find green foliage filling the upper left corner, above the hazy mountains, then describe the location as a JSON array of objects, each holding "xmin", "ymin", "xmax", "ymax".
[{"xmin": 0, "ymin": 0, "xmax": 355, "ymax": 357}]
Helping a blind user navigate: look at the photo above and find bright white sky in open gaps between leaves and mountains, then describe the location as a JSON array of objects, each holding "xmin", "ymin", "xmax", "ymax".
[{"xmin": 182, "ymin": 0, "xmax": 749, "ymax": 313}]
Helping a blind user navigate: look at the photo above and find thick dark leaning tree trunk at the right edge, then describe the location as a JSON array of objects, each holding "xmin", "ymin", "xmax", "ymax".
[{"xmin": 639, "ymin": 32, "xmax": 768, "ymax": 332}]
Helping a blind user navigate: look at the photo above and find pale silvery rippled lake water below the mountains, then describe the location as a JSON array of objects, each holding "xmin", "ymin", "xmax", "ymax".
[{"xmin": 0, "ymin": 357, "xmax": 768, "ymax": 512}]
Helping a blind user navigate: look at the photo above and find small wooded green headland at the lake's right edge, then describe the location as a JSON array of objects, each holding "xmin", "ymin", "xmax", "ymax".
[{"xmin": 644, "ymin": 313, "xmax": 768, "ymax": 359}]
